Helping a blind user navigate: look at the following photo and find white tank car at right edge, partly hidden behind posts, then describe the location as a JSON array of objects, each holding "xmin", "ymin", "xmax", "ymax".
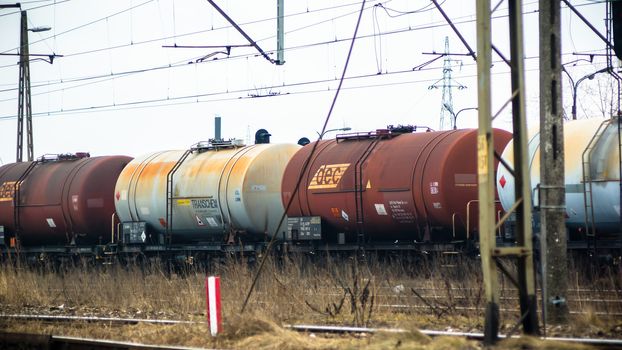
[{"xmin": 497, "ymin": 118, "xmax": 620, "ymax": 237}]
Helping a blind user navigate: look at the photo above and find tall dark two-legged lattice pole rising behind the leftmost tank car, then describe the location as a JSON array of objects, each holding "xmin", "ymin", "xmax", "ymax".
[{"xmin": 16, "ymin": 11, "xmax": 34, "ymax": 162}]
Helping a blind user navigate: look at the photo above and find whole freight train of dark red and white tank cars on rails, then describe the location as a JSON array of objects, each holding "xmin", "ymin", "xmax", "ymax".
[{"xmin": 0, "ymin": 121, "xmax": 620, "ymax": 262}]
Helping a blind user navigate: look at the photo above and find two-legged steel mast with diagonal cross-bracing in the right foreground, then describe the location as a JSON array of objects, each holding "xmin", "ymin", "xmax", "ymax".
[{"xmin": 477, "ymin": 0, "xmax": 539, "ymax": 344}]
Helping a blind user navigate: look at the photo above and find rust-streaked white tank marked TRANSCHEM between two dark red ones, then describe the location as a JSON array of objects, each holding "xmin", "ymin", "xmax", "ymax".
[{"xmin": 115, "ymin": 144, "xmax": 300, "ymax": 243}]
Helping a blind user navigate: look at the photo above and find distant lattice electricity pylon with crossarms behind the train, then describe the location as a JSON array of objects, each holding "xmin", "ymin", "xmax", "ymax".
[{"xmin": 428, "ymin": 37, "xmax": 466, "ymax": 130}]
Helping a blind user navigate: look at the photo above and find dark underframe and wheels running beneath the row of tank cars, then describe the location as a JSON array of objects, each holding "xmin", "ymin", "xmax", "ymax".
[{"xmin": 0, "ymin": 226, "xmax": 622, "ymax": 266}]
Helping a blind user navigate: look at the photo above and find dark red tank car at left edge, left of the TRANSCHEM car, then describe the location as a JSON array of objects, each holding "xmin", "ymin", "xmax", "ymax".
[{"xmin": 0, "ymin": 154, "xmax": 132, "ymax": 246}]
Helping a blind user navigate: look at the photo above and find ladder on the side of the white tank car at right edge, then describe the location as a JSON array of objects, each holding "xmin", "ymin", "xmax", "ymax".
[{"xmin": 582, "ymin": 119, "xmax": 610, "ymax": 256}]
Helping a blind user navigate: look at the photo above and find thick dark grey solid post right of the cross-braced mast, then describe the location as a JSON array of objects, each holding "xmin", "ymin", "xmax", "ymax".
[{"xmin": 539, "ymin": 0, "xmax": 581, "ymax": 324}]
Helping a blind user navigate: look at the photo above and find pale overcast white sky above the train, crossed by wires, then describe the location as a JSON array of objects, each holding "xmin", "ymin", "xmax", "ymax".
[{"xmin": 0, "ymin": 0, "xmax": 617, "ymax": 164}]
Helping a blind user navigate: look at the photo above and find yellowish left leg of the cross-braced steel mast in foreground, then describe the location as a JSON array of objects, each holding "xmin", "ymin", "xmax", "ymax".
[{"xmin": 476, "ymin": 0, "xmax": 499, "ymax": 345}]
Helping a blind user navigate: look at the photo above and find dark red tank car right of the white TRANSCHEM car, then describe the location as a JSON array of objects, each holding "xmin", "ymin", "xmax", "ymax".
[{"xmin": 282, "ymin": 129, "xmax": 511, "ymax": 242}]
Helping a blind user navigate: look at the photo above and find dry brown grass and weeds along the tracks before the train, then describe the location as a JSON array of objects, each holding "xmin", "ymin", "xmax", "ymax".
[{"xmin": 0, "ymin": 257, "xmax": 622, "ymax": 349}]
